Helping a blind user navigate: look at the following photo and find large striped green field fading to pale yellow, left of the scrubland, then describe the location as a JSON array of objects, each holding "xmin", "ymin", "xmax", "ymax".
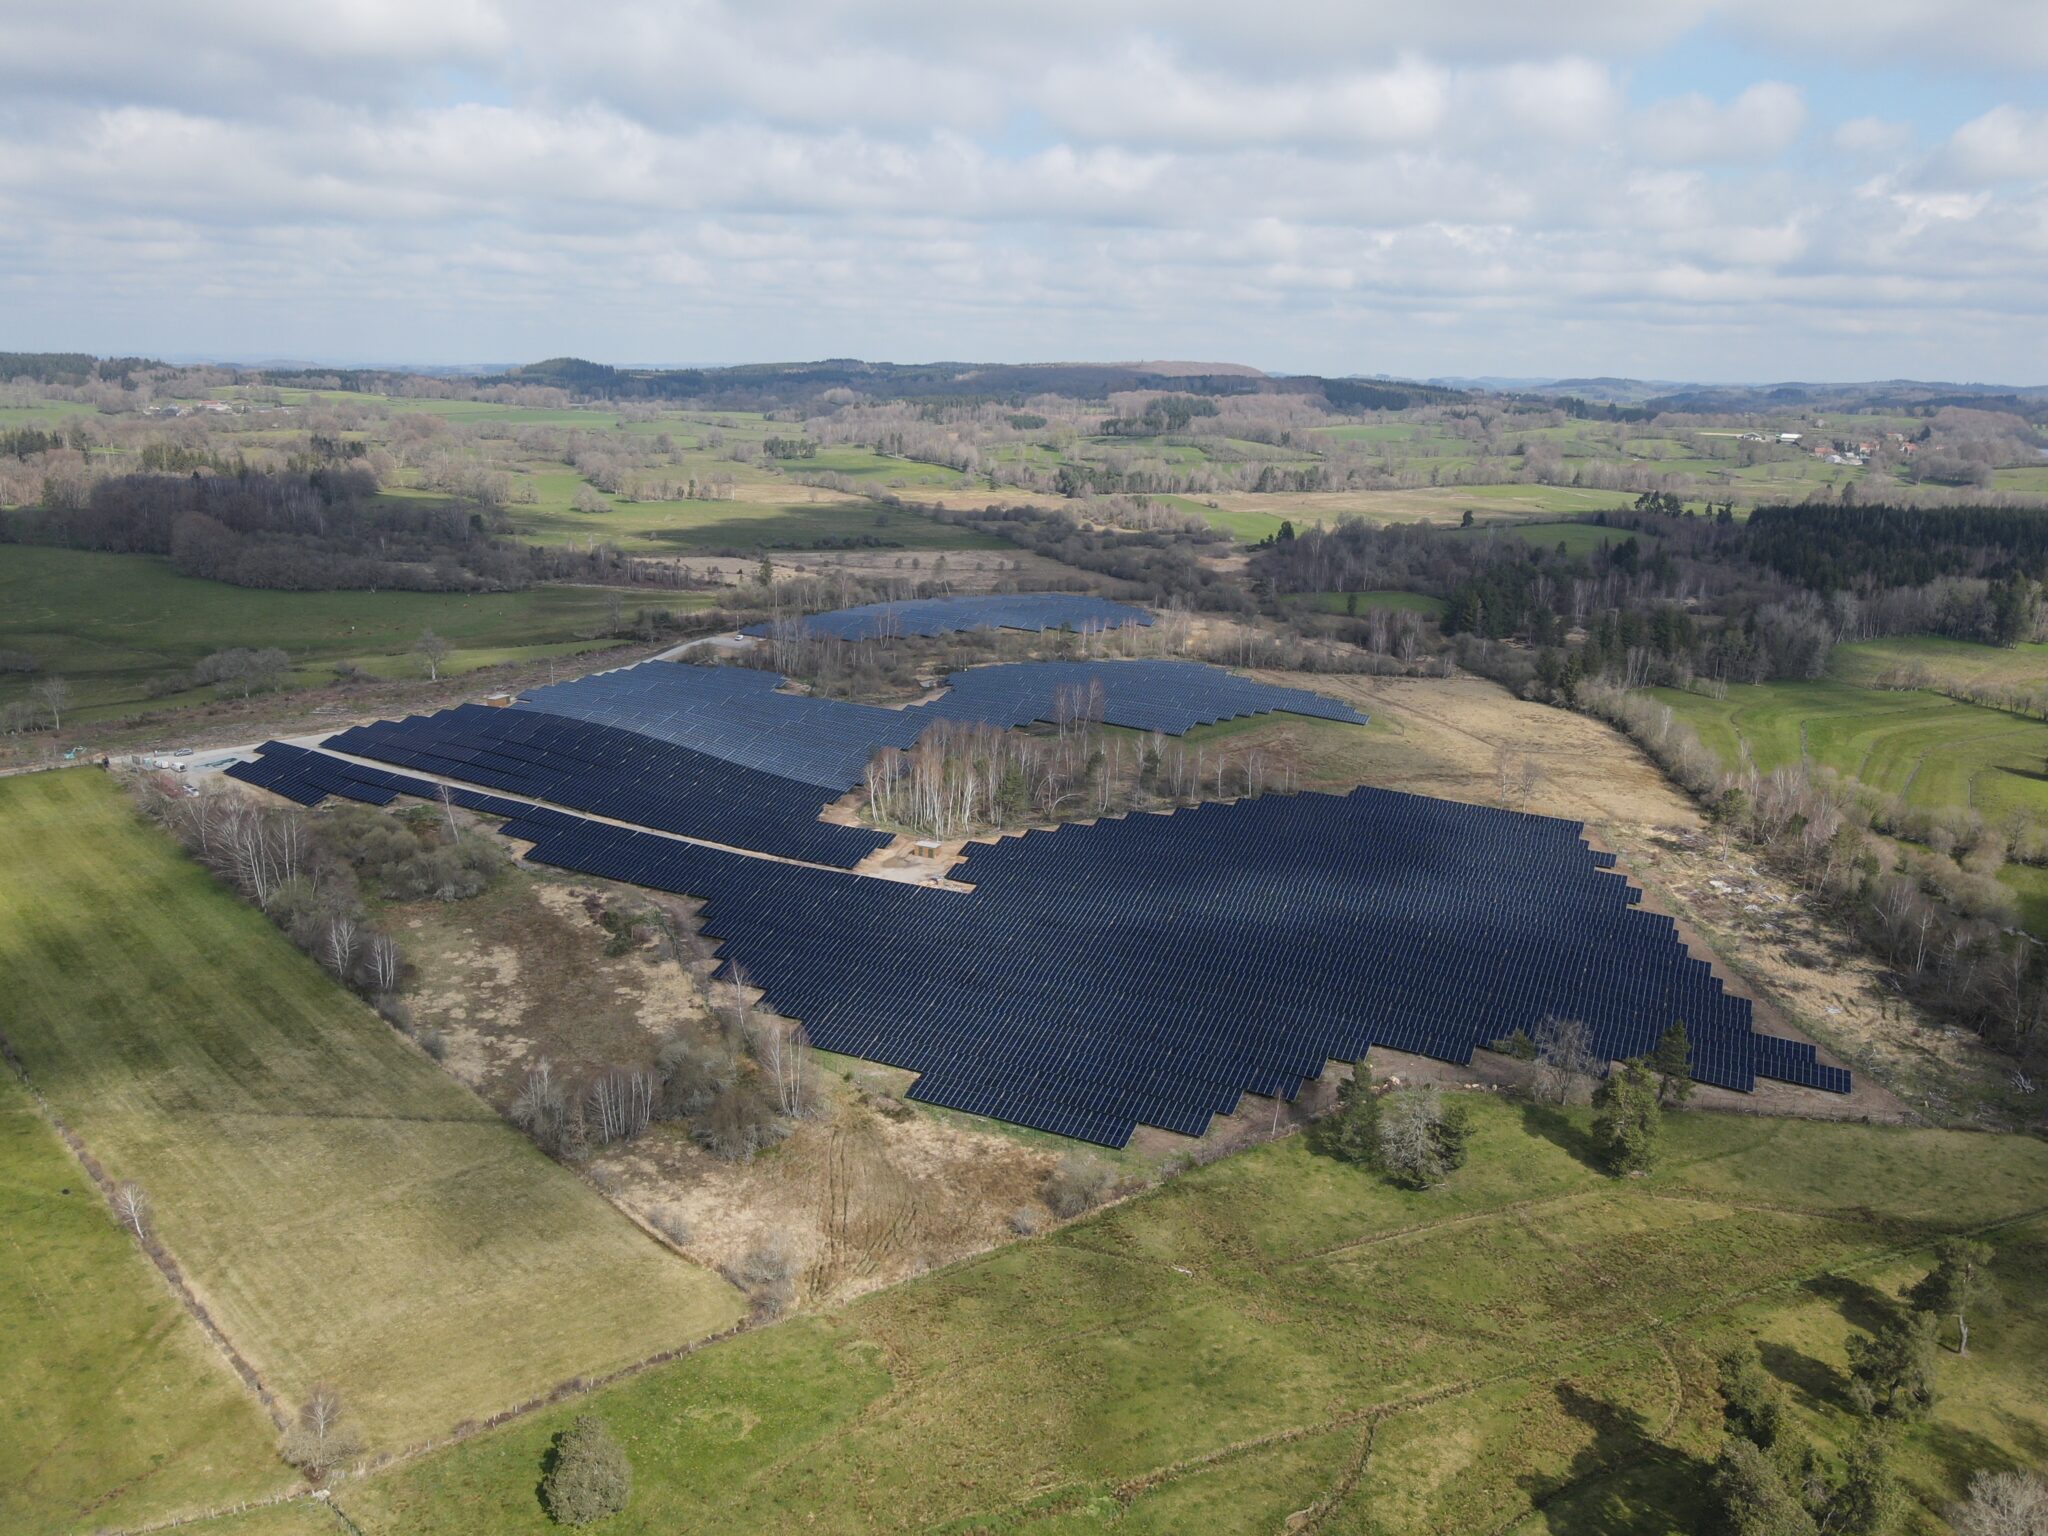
[{"xmin": 0, "ymin": 768, "xmax": 741, "ymax": 1446}]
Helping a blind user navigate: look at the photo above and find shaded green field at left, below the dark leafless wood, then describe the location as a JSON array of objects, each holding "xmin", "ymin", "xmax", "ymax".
[{"xmin": 0, "ymin": 545, "xmax": 711, "ymax": 721}]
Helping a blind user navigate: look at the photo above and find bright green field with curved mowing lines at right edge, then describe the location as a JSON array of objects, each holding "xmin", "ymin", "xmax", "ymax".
[{"xmin": 1655, "ymin": 678, "xmax": 2048, "ymax": 819}]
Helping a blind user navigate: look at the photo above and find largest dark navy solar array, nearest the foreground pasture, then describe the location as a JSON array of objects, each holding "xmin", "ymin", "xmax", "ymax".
[{"xmin": 233, "ymin": 743, "xmax": 1849, "ymax": 1147}]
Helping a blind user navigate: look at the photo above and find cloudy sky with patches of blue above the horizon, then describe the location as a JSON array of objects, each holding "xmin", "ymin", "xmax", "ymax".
[{"xmin": 0, "ymin": 0, "xmax": 2048, "ymax": 383}]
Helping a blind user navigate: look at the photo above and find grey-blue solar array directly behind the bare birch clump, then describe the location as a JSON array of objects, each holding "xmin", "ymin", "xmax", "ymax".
[{"xmin": 520, "ymin": 662, "xmax": 1366, "ymax": 791}]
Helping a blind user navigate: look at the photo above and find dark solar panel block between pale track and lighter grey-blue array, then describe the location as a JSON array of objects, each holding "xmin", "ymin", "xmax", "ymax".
[{"xmin": 311, "ymin": 705, "xmax": 889, "ymax": 868}]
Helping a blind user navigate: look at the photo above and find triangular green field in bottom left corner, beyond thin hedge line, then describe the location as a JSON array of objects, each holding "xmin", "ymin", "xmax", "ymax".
[{"xmin": 0, "ymin": 1065, "xmax": 291, "ymax": 1536}]
